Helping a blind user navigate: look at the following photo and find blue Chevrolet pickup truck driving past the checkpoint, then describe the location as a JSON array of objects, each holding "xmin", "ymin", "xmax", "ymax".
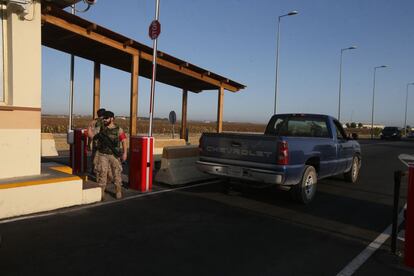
[{"xmin": 197, "ymin": 114, "xmax": 361, "ymax": 204}]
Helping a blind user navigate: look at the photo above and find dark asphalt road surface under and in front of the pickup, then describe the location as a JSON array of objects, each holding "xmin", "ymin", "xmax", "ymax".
[{"xmin": 0, "ymin": 141, "xmax": 414, "ymax": 276}]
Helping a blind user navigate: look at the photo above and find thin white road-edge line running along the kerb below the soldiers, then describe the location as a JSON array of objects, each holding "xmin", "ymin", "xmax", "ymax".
[{"xmin": 0, "ymin": 179, "xmax": 222, "ymax": 224}]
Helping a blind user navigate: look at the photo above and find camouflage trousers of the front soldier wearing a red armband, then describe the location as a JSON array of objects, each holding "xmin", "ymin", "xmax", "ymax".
[{"xmin": 93, "ymin": 151, "xmax": 122, "ymax": 193}]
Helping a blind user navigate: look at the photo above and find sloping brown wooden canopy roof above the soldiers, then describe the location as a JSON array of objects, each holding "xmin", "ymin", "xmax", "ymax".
[{"xmin": 42, "ymin": 0, "xmax": 245, "ymax": 93}]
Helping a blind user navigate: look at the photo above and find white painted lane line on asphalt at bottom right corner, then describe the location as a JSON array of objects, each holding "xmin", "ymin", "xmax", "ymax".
[{"xmin": 337, "ymin": 204, "xmax": 407, "ymax": 276}]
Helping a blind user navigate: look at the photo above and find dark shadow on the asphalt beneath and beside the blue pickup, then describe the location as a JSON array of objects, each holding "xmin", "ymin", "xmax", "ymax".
[{"xmin": 180, "ymin": 176, "xmax": 398, "ymax": 243}]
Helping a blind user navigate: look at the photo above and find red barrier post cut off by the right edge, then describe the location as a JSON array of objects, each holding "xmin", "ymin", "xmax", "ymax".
[{"xmin": 404, "ymin": 164, "xmax": 414, "ymax": 267}]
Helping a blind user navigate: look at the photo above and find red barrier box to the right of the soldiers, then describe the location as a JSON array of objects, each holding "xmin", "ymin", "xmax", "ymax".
[{"xmin": 129, "ymin": 136, "xmax": 154, "ymax": 192}]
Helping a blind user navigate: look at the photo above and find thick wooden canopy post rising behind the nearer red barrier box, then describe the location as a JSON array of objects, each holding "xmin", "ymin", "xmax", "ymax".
[{"xmin": 129, "ymin": 55, "xmax": 139, "ymax": 136}]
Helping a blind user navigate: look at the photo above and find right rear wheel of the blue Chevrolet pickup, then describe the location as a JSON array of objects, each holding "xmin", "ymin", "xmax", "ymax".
[{"xmin": 291, "ymin": 166, "xmax": 318, "ymax": 204}]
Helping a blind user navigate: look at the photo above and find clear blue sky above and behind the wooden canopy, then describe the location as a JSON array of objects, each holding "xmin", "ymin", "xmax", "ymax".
[{"xmin": 42, "ymin": 0, "xmax": 414, "ymax": 126}]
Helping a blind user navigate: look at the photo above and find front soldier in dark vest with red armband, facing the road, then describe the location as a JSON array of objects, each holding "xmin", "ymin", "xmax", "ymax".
[{"xmin": 94, "ymin": 111, "xmax": 127, "ymax": 199}]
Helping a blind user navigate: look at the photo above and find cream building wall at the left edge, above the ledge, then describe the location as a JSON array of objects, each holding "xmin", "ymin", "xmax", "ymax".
[{"xmin": 0, "ymin": 2, "xmax": 41, "ymax": 179}]
